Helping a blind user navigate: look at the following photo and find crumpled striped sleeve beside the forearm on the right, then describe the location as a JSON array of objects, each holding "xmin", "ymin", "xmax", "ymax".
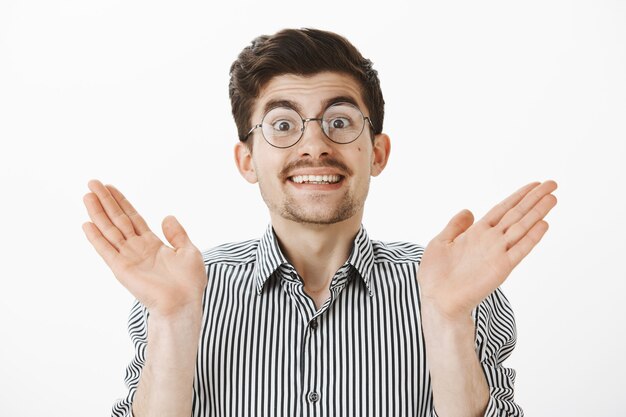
[{"xmin": 474, "ymin": 289, "xmax": 524, "ymax": 417}]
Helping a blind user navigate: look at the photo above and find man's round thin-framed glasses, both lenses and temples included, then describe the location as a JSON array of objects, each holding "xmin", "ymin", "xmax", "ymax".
[{"xmin": 243, "ymin": 103, "xmax": 374, "ymax": 148}]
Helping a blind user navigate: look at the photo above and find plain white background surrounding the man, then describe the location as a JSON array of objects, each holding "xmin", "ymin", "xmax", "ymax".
[{"xmin": 0, "ymin": 0, "xmax": 626, "ymax": 416}]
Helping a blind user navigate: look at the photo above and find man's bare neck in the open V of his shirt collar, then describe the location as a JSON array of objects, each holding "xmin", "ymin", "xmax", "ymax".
[{"xmin": 272, "ymin": 213, "xmax": 363, "ymax": 308}]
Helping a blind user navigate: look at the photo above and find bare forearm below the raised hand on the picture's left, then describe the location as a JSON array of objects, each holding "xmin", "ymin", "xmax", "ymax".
[{"xmin": 133, "ymin": 306, "xmax": 202, "ymax": 417}]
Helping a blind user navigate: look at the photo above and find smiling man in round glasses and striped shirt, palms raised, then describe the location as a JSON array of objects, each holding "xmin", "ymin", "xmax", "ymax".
[{"xmin": 83, "ymin": 29, "xmax": 556, "ymax": 417}]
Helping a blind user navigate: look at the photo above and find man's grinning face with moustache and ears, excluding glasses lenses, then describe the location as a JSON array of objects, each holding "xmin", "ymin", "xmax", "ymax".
[{"xmin": 236, "ymin": 72, "xmax": 389, "ymax": 225}]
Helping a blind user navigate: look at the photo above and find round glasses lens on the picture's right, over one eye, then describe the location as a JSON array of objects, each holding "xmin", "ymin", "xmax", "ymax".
[{"xmin": 322, "ymin": 103, "xmax": 365, "ymax": 143}]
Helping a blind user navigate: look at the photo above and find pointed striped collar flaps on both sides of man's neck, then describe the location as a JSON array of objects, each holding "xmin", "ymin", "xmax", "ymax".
[{"xmin": 253, "ymin": 224, "xmax": 374, "ymax": 295}]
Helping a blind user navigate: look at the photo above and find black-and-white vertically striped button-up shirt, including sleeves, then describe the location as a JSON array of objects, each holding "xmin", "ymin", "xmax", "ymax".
[{"xmin": 112, "ymin": 226, "xmax": 523, "ymax": 417}]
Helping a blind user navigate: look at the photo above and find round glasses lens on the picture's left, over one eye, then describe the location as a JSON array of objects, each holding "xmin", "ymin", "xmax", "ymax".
[{"xmin": 262, "ymin": 107, "xmax": 302, "ymax": 148}]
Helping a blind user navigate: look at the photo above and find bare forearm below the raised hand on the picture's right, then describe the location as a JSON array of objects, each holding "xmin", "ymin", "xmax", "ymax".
[{"xmin": 421, "ymin": 302, "xmax": 489, "ymax": 417}]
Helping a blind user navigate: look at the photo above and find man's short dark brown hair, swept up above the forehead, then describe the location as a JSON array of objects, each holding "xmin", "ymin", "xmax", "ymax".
[{"xmin": 228, "ymin": 29, "xmax": 385, "ymax": 145}]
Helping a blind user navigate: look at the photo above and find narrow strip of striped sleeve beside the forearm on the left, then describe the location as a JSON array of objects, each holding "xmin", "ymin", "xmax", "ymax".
[{"xmin": 111, "ymin": 301, "xmax": 148, "ymax": 417}]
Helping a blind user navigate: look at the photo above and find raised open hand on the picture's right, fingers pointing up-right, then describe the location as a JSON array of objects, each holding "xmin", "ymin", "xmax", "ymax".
[{"xmin": 417, "ymin": 181, "xmax": 557, "ymax": 319}]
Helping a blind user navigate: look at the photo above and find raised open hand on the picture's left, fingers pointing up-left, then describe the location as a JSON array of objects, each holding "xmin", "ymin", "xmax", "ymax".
[{"xmin": 83, "ymin": 180, "xmax": 207, "ymax": 317}]
